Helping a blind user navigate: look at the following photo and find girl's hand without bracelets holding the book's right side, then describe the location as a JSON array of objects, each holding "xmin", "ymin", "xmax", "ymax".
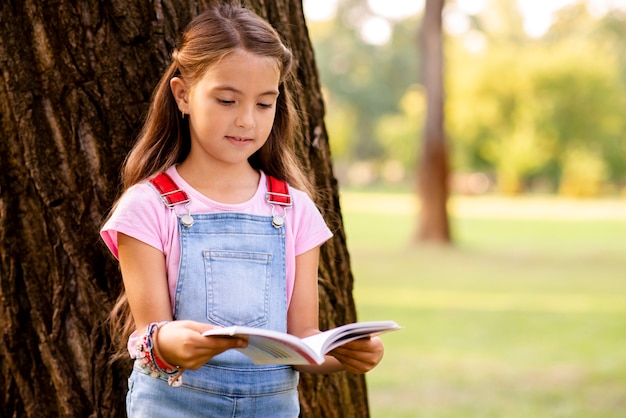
[{"xmin": 329, "ymin": 337, "xmax": 384, "ymax": 374}]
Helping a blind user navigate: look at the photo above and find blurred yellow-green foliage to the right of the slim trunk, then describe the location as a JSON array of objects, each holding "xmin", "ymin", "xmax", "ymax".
[{"xmin": 448, "ymin": 35, "xmax": 626, "ymax": 195}]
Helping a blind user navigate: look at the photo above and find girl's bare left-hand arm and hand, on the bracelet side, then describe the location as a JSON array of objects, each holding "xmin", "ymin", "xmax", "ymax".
[{"xmin": 118, "ymin": 233, "xmax": 246, "ymax": 369}]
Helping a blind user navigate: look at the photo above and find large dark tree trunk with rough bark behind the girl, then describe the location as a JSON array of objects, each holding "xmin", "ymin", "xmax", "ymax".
[{"xmin": 0, "ymin": 0, "xmax": 368, "ymax": 417}]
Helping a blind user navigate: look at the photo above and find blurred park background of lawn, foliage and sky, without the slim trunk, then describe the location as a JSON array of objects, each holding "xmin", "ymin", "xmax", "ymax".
[{"xmin": 304, "ymin": 0, "xmax": 626, "ymax": 418}]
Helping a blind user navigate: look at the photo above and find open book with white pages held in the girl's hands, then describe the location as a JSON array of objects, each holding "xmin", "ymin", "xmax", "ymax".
[{"xmin": 202, "ymin": 321, "xmax": 400, "ymax": 364}]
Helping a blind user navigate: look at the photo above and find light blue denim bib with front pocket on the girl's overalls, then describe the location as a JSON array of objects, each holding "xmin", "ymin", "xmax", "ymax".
[{"xmin": 174, "ymin": 213, "xmax": 287, "ymax": 366}]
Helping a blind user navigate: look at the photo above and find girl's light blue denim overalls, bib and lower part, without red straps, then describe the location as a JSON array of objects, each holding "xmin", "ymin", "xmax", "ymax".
[{"xmin": 127, "ymin": 174, "xmax": 299, "ymax": 418}]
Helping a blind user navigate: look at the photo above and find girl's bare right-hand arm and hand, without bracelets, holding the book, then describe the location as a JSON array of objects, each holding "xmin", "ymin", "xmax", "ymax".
[{"xmin": 287, "ymin": 247, "xmax": 383, "ymax": 374}]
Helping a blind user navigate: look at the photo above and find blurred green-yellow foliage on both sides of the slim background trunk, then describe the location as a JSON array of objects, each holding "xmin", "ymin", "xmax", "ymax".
[{"xmin": 311, "ymin": 0, "xmax": 626, "ymax": 196}]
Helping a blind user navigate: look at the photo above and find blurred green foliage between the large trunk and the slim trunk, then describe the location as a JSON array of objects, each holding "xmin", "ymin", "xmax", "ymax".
[{"xmin": 309, "ymin": 0, "xmax": 418, "ymax": 161}]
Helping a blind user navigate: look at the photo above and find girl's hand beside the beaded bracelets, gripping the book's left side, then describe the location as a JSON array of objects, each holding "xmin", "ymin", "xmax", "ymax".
[{"xmin": 153, "ymin": 320, "xmax": 248, "ymax": 369}]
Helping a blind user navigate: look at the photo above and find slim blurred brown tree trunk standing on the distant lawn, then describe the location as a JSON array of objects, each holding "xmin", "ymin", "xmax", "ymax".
[{"xmin": 416, "ymin": 0, "xmax": 451, "ymax": 243}]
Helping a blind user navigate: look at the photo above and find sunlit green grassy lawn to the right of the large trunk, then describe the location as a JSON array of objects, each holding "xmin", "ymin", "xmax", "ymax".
[{"xmin": 342, "ymin": 192, "xmax": 626, "ymax": 418}]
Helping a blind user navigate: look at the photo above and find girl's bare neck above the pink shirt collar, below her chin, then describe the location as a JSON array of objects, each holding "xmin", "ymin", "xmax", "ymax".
[{"xmin": 176, "ymin": 162, "xmax": 261, "ymax": 204}]
